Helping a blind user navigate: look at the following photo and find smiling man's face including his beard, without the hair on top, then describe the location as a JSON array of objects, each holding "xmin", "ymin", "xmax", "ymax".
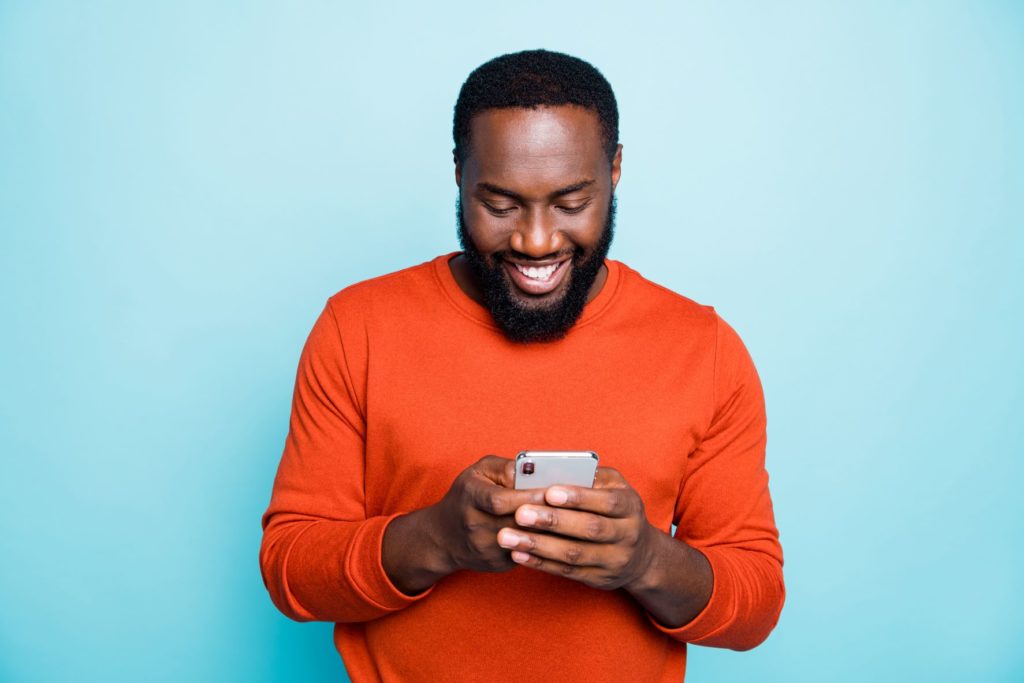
[{"xmin": 456, "ymin": 105, "xmax": 622, "ymax": 342}]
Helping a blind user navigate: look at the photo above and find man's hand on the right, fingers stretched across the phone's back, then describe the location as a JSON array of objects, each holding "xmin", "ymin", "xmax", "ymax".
[{"xmin": 498, "ymin": 467, "xmax": 659, "ymax": 591}]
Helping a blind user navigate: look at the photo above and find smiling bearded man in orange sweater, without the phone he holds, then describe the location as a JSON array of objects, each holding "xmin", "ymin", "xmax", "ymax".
[{"xmin": 260, "ymin": 50, "xmax": 783, "ymax": 681}]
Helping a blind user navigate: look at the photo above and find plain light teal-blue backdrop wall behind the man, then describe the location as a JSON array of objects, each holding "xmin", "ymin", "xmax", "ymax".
[{"xmin": 0, "ymin": 0, "xmax": 1024, "ymax": 681}]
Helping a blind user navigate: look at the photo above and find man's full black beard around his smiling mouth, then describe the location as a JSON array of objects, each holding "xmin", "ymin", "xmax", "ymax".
[{"xmin": 455, "ymin": 196, "xmax": 615, "ymax": 343}]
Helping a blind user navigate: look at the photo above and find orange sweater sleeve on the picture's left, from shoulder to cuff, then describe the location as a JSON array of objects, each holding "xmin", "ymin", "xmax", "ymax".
[{"xmin": 260, "ymin": 302, "xmax": 429, "ymax": 623}]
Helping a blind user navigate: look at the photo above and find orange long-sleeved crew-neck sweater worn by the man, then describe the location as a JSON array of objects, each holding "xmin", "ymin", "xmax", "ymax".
[{"xmin": 260, "ymin": 254, "xmax": 783, "ymax": 681}]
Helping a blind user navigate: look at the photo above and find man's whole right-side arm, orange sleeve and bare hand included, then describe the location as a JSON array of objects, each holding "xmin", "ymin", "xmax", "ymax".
[{"xmin": 499, "ymin": 321, "xmax": 784, "ymax": 649}]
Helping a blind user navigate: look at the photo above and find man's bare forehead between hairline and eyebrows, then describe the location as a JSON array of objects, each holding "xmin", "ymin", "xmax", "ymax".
[{"xmin": 466, "ymin": 105, "xmax": 607, "ymax": 183}]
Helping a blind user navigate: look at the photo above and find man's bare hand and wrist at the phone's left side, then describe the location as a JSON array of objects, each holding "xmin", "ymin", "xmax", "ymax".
[{"xmin": 381, "ymin": 456, "xmax": 544, "ymax": 595}]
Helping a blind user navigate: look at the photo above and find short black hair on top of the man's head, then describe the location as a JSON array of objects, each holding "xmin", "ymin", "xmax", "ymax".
[{"xmin": 452, "ymin": 50, "xmax": 618, "ymax": 163}]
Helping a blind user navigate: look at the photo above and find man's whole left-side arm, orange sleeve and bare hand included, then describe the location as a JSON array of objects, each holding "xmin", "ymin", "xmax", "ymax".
[{"xmin": 260, "ymin": 303, "xmax": 544, "ymax": 622}]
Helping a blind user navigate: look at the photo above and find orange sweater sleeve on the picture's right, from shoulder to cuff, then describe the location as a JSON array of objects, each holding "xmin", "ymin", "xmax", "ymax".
[{"xmin": 652, "ymin": 318, "xmax": 785, "ymax": 650}]
